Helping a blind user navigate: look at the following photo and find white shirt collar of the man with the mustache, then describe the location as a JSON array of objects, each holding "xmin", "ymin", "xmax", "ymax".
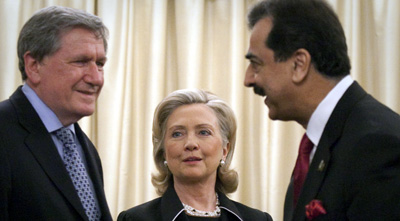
[{"xmin": 307, "ymin": 75, "xmax": 354, "ymax": 146}]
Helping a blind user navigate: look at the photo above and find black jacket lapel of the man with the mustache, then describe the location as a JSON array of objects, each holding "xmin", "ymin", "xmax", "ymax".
[{"xmin": 293, "ymin": 82, "xmax": 367, "ymax": 220}]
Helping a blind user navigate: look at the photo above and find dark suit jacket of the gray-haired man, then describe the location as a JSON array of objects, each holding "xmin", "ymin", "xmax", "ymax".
[{"xmin": 0, "ymin": 87, "xmax": 111, "ymax": 220}]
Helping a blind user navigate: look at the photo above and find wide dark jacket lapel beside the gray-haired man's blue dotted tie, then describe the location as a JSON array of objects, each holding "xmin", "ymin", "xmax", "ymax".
[{"xmin": 10, "ymin": 88, "xmax": 87, "ymax": 219}]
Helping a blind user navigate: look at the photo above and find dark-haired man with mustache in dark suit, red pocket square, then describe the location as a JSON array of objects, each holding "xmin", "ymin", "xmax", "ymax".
[{"xmin": 244, "ymin": 0, "xmax": 400, "ymax": 220}]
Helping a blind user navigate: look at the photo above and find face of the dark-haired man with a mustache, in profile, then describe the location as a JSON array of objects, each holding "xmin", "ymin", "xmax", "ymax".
[{"xmin": 244, "ymin": 17, "xmax": 293, "ymax": 120}]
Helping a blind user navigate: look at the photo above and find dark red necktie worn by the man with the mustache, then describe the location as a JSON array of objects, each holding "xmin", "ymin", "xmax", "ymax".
[{"xmin": 293, "ymin": 134, "xmax": 314, "ymax": 206}]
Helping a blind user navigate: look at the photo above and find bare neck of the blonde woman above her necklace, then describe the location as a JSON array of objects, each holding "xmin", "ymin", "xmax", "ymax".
[{"xmin": 174, "ymin": 180, "xmax": 217, "ymax": 211}]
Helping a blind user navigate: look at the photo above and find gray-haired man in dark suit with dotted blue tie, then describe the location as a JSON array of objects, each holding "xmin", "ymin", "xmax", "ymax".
[{"xmin": 0, "ymin": 7, "xmax": 111, "ymax": 220}]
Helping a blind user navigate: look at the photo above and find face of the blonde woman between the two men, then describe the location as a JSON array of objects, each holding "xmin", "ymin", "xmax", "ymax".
[{"xmin": 164, "ymin": 104, "xmax": 229, "ymax": 184}]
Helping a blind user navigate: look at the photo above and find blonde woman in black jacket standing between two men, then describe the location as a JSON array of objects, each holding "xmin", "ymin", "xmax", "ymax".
[{"xmin": 118, "ymin": 89, "xmax": 272, "ymax": 221}]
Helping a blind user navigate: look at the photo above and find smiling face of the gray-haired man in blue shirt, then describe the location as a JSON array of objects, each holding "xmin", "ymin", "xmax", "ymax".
[{"xmin": 30, "ymin": 28, "xmax": 106, "ymax": 125}]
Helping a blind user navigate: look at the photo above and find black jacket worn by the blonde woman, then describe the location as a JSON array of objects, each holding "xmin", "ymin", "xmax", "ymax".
[{"xmin": 118, "ymin": 185, "xmax": 272, "ymax": 221}]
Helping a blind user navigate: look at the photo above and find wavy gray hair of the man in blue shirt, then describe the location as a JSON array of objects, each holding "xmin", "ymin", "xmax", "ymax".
[{"xmin": 18, "ymin": 6, "xmax": 108, "ymax": 80}]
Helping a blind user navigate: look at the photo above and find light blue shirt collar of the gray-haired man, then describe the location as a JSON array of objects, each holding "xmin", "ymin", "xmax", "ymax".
[{"xmin": 22, "ymin": 83, "xmax": 75, "ymax": 133}]
